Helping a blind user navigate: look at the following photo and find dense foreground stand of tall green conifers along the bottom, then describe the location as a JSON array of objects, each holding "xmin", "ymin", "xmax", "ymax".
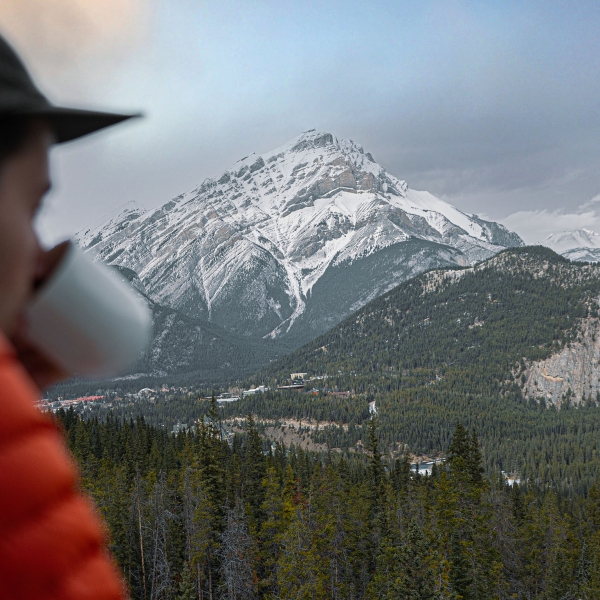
[{"xmin": 57, "ymin": 402, "xmax": 600, "ymax": 600}]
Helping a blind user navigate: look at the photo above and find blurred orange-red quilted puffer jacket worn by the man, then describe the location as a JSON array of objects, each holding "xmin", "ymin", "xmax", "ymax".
[{"xmin": 0, "ymin": 334, "xmax": 126, "ymax": 600}]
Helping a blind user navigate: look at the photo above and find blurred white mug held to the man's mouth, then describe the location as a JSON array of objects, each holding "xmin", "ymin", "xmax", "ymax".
[{"xmin": 26, "ymin": 243, "xmax": 152, "ymax": 377}]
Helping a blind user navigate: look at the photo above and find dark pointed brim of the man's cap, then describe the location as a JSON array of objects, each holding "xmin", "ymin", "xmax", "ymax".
[{"xmin": 21, "ymin": 106, "xmax": 142, "ymax": 144}]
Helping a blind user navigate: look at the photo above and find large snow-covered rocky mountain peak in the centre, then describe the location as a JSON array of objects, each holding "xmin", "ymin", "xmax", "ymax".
[{"xmin": 78, "ymin": 130, "xmax": 523, "ymax": 345}]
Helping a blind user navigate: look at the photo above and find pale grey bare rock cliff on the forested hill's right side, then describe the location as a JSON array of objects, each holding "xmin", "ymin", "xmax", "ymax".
[{"xmin": 523, "ymin": 318, "xmax": 600, "ymax": 406}]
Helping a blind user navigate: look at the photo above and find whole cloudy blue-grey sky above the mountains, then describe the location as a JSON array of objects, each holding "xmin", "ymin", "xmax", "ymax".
[{"xmin": 0, "ymin": 0, "xmax": 600, "ymax": 243}]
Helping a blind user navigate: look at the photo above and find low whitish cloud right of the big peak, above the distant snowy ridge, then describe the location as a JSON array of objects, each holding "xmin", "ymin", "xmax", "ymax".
[{"xmin": 500, "ymin": 206, "xmax": 600, "ymax": 244}]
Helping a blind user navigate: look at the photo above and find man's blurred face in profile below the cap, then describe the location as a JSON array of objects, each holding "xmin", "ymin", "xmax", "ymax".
[{"xmin": 0, "ymin": 122, "xmax": 53, "ymax": 335}]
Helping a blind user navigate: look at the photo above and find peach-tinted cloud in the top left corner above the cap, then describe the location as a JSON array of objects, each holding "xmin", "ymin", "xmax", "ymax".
[{"xmin": 0, "ymin": 0, "xmax": 155, "ymax": 97}]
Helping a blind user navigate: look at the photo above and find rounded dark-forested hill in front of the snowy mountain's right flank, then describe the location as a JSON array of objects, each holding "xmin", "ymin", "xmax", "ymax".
[{"xmin": 263, "ymin": 247, "xmax": 600, "ymax": 391}]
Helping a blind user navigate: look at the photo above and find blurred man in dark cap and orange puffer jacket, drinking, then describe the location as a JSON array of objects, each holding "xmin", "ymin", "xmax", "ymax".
[{"xmin": 0, "ymin": 37, "xmax": 135, "ymax": 600}]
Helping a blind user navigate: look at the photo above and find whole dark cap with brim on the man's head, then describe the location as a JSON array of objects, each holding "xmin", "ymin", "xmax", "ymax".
[{"xmin": 0, "ymin": 35, "xmax": 140, "ymax": 144}]
